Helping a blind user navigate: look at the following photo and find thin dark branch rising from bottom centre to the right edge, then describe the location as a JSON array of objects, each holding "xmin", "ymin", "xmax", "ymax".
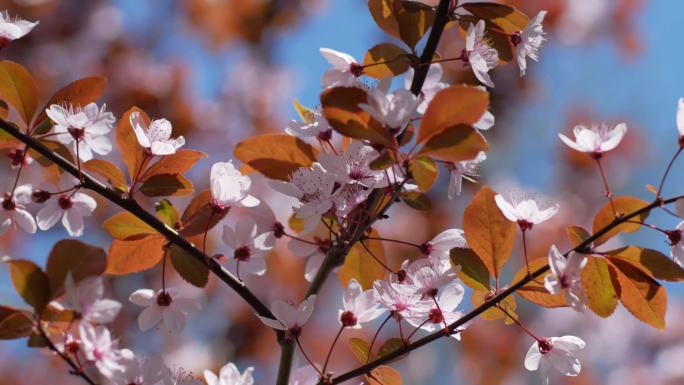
[{"xmin": 326, "ymin": 195, "xmax": 684, "ymax": 385}]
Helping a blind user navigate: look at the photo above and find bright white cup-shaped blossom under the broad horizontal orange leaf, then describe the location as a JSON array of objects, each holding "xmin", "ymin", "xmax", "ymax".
[{"xmin": 210, "ymin": 160, "xmax": 259, "ymax": 211}]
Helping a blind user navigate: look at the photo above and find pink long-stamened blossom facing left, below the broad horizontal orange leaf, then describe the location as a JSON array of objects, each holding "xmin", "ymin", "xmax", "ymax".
[{"xmin": 269, "ymin": 163, "xmax": 335, "ymax": 233}]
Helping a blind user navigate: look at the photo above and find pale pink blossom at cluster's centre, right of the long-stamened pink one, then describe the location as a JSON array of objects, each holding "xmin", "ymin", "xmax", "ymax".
[{"xmin": 318, "ymin": 140, "xmax": 387, "ymax": 188}]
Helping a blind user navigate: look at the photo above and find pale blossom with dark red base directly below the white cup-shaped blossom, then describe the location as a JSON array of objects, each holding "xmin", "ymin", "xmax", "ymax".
[{"xmin": 223, "ymin": 218, "xmax": 275, "ymax": 277}]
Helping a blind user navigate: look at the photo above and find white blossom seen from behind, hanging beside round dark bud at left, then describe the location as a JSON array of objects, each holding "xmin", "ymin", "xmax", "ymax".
[{"xmin": 36, "ymin": 188, "xmax": 97, "ymax": 237}]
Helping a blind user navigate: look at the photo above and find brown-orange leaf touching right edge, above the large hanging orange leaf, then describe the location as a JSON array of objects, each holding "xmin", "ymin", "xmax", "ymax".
[{"xmin": 604, "ymin": 246, "xmax": 684, "ymax": 281}]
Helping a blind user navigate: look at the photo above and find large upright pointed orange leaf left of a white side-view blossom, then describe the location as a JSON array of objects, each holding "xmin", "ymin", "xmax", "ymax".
[{"xmin": 463, "ymin": 186, "xmax": 515, "ymax": 280}]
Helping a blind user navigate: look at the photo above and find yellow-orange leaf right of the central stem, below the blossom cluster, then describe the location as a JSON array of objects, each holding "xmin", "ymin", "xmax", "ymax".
[{"xmin": 337, "ymin": 230, "xmax": 387, "ymax": 290}]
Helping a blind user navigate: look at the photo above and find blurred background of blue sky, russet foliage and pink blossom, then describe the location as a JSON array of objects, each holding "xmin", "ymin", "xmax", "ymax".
[{"xmin": 0, "ymin": 0, "xmax": 684, "ymax": 385}]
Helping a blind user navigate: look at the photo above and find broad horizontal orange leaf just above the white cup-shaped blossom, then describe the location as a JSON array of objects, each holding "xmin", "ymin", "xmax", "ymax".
[{"xmin": 233, "ymin": 134, "xmax": 318, "ymax": 181}]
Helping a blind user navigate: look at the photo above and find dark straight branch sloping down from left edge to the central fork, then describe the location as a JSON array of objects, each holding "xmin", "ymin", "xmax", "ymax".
[{"xmin": 0, "ymin": 119, "xmax": 283, "ymax": 330}]
